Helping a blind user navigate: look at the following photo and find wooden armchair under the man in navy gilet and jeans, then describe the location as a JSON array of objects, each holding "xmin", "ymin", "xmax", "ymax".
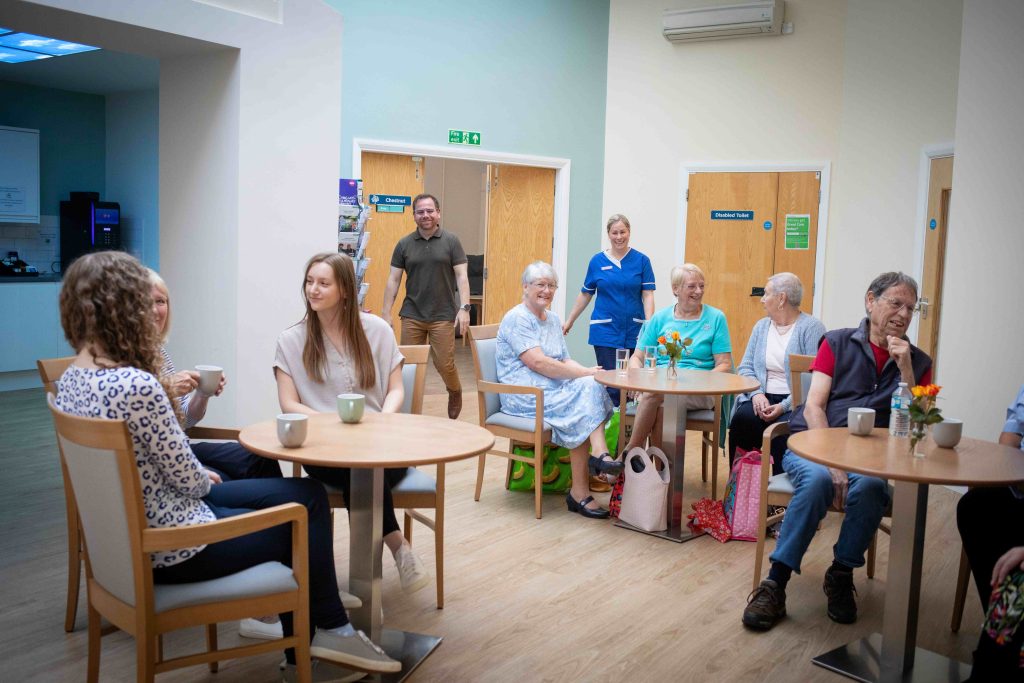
[{"xmin": 754, "ymin": 353, "xmax": 891, "ymax": 589}]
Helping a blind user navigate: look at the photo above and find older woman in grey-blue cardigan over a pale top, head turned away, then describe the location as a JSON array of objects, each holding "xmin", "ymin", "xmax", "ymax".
[{"xmin": 729, "ymin": 272, "xmax": 825, "ymax": 466}]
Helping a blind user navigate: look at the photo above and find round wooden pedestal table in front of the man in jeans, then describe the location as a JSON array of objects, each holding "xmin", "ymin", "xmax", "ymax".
[{"xmin": 788, "ymin": 427, "xmax": 1024, "ymax": 681}]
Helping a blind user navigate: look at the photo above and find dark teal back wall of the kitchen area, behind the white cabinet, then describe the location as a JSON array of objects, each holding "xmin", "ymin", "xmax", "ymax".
[{"xmin": 0, "ymin": 81, "xmax": 106, "ymax": 216}]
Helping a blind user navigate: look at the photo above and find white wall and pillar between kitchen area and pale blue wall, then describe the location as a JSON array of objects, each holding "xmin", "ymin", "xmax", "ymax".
[{"xmin": 22, "ymin": 0, "xmax": 341, "ymax": 424}]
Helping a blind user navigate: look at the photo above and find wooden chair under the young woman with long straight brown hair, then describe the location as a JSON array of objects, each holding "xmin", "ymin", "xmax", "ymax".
[{"xmin": 292, "ymin": 344, "xmax": 444, "ymax": 609}]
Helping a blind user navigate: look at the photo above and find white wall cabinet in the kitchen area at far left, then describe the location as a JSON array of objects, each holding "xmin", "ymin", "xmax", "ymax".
[{"xmin": 0, "ymin": 126, "xmax": 39, "ymax": 223}]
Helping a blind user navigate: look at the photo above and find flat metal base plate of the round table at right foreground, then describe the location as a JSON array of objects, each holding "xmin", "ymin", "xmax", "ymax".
[{"xmin": 812, "ymin": 633, "xmax": 971, "ymax": 683}]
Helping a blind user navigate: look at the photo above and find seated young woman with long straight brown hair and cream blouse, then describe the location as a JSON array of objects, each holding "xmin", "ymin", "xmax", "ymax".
[{"xmin": 273, "ymin": 252, "xmax": 430, "ymax": 593}]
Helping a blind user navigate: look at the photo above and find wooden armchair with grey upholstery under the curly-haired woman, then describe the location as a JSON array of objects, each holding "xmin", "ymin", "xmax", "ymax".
[{"xmin": 49, "ymin": 396, "xmax": 311, "ymax": 683}]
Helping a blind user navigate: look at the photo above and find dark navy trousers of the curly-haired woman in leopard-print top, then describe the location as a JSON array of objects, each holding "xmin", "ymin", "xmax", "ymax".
[{"xmin": 153, "ymin": 477, "xmax": 348, "ymax": 664}]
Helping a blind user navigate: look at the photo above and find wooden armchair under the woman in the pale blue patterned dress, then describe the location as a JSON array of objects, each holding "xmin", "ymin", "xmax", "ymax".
[{"xmin": 469, "ymin": 325, "xmax": 551, "ymax": 519}]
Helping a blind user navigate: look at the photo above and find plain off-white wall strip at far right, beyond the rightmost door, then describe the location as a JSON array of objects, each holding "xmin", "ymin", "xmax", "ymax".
[{"xmin": 938, "ymin": 0, "xmax": 1024, "ymax": 439}]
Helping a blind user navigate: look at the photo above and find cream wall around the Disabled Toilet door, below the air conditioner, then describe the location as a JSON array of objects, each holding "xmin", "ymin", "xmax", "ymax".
[{"xmin": 603, "ymin": 0, "xmax": 961, "ymax": 327}]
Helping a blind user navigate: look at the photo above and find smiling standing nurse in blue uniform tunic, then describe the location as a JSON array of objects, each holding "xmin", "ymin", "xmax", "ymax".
[{"xmin": 562, "ymin": 213, "xmax": 654, "ymax": 405}]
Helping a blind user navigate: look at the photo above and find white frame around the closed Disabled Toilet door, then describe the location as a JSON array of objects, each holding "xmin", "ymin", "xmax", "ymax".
[{"xmin": 675, "ymin": 161, "xmax": 831, "ymax": 319}]
